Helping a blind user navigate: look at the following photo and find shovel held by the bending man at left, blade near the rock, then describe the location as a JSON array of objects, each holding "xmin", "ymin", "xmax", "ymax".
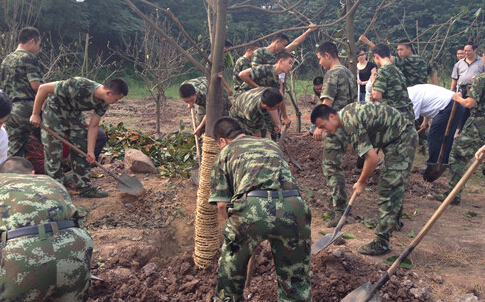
[{"xmin": 40, "ymin": 123, "xmax": 144, "ymax": 195}]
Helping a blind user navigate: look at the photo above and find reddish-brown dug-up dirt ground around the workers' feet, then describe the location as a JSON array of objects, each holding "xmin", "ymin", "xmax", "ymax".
[{"xmin": 73, "ymin": 96, "xmax": 485, "ymax": 301}]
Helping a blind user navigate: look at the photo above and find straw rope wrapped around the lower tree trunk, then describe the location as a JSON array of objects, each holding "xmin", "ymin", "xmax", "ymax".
[{"xmin": 194, "ymin": 135, "xmax": 220, "ymax": 268}]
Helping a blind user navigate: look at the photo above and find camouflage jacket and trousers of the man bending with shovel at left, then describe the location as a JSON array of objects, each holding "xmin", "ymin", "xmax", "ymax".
[{"xmin": 41, "ymin": 77, "xmax": 104, "ymax": 191}]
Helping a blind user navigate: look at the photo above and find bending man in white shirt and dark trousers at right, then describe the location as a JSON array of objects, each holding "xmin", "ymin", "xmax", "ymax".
[{"xmin": 408, "ymin": 84, "xmax": 465, "ymax": 164}]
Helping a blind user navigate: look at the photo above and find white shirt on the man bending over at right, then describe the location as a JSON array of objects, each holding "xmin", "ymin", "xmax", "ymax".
[{"xmin": 408, "ymin": 84, "xmax": 454, "ymax": 119}]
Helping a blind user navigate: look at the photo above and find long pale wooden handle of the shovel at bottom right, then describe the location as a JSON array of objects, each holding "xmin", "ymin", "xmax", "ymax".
[{"xmin": 364, "ymin": 154, "xmax": 483, "ymax": 301}]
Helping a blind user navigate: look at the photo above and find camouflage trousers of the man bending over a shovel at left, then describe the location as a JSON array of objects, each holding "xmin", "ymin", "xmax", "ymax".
[{"xmin": 42, "ymin": 107, "xmax": 91, "ymax": 190}]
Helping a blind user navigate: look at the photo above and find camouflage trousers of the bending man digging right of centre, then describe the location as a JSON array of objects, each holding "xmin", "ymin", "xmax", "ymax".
[{"xmin": 375, "ymin": 126, "xmax": 418, "ymax": 242}]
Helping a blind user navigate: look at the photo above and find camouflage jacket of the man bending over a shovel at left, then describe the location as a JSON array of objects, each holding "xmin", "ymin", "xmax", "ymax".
[{"xmin": 46, "ymin": 77, "xmax": 109, "ymax": 117}]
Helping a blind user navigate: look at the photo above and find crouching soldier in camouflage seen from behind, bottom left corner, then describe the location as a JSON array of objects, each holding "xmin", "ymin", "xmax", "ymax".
[{"xmin": 0, "ymin": 157, "xmax": 93, "ymax": 302}]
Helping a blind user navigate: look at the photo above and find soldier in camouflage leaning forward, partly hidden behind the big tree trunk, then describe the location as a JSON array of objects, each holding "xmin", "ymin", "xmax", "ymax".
[{"xmin": 179, "ymin": 77, "xmax": 231, "ymax": 136}]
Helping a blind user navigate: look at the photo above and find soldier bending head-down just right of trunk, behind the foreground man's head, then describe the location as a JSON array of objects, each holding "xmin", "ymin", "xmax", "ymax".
[{"xmin": 229, "ymin": 87, "xmax": 283, "ymax": 137}]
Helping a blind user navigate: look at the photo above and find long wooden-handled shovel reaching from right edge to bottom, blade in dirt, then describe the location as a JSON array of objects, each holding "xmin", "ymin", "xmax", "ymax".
[{"xmin": 341, "ymin": 154, "xmax": 483, "ymax": 302}]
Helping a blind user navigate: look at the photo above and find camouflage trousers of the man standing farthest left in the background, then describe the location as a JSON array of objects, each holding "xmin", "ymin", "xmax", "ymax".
[{"xmin": 5, "ymin": 100, "xmax": 35, "ymax": 157}]
